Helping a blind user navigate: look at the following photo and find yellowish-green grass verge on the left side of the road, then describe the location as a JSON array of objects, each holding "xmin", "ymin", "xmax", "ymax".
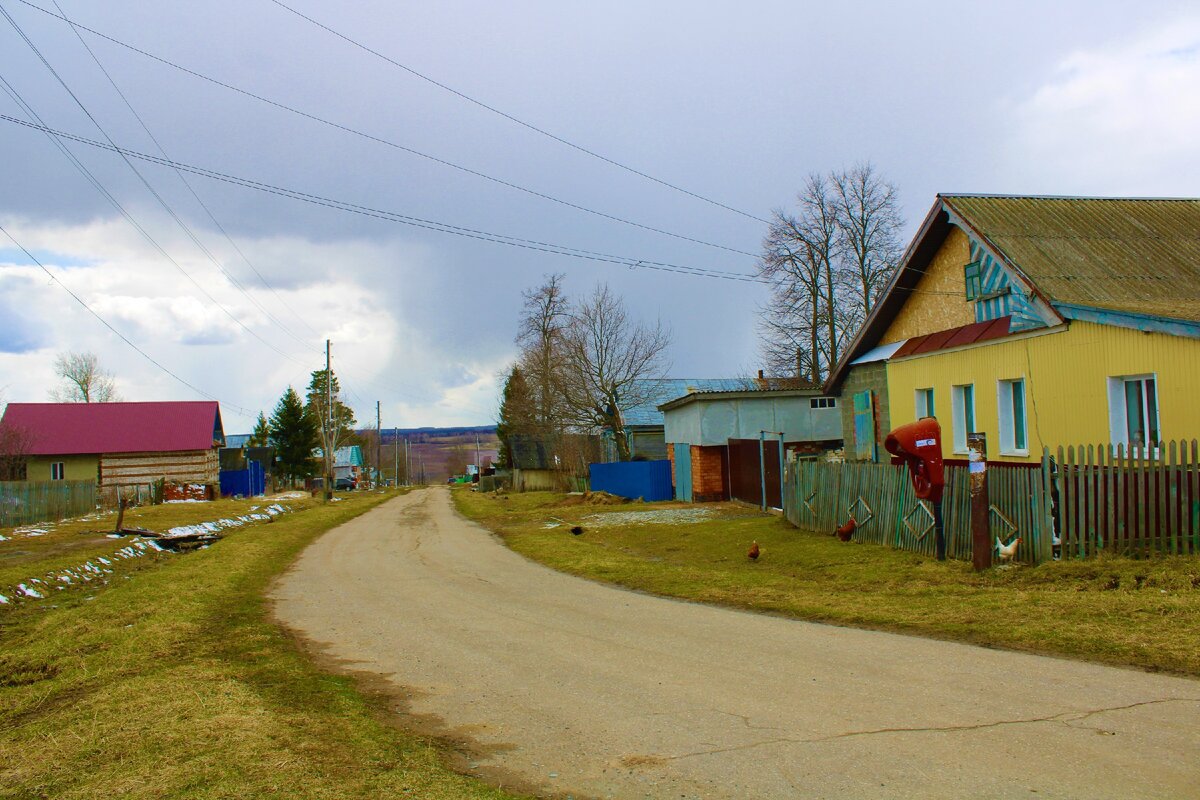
[{"xmin": 0, "ymin": 493, "xmax": 525, "ymax": 799}]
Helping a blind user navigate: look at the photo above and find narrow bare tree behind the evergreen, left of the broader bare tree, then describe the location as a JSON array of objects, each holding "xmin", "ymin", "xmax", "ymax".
[{"xmin": 516, "ymin": 273, "xmax": 570, "ymax": 433}]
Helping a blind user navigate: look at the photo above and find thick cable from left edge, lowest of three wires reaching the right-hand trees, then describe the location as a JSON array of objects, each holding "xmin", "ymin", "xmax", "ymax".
[{"xmin": 0, "ymin": 114, "xmax": 766, "ymax": 283}]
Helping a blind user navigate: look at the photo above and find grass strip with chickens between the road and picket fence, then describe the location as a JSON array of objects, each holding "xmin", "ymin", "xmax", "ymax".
[{"xmin": 454, "ymin": 491, "xmax": 1200, "ymax": 675}]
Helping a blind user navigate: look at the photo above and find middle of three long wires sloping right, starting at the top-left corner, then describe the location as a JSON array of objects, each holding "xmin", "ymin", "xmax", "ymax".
[{"xmin": 11, "ymin": 0, "xmax": 756, "ymax": 258}]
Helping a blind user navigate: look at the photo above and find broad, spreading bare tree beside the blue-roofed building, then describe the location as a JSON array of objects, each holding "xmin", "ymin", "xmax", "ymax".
[{"xmin": 556, "ymin": 284, "xmax": 671, "ymax": 461}]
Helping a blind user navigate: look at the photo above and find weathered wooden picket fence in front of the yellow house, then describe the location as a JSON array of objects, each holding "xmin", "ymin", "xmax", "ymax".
[{"xmin": 784, "ymin": 440, "xmax": 1200, "ymax": 564}]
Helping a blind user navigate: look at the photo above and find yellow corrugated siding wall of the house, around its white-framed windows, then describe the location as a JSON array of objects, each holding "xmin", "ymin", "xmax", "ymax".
[{"xmin": 888, "ymin": 321, "xmax": 1200, "ymax": 462}]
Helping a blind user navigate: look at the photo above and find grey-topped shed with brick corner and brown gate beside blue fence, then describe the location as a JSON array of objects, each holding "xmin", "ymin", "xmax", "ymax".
[{"xmin": 660, "ymin": 389, "xmax": 842, "ymax": 507}]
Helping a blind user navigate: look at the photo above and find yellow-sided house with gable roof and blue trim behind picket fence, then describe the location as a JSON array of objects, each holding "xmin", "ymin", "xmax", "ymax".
[{"xmin": 826, "ymin": 194, "xmax": 1200, "ymax": 462}]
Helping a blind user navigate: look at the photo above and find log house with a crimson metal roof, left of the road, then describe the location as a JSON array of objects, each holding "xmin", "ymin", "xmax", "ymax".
[{"xmin": 0, "ymin": 401, "xmax": 224, "ymax": 488}]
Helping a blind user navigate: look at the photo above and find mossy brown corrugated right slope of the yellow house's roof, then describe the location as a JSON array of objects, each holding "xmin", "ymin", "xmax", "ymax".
[{"xmin": 942, "ymin": 194, "xmax": 1200, "ymax": 321}]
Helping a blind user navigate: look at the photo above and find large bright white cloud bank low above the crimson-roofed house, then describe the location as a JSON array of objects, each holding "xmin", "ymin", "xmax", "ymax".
[{"xmin": 0, "ymin": 214, "xmax": 506, "ymax": 432}]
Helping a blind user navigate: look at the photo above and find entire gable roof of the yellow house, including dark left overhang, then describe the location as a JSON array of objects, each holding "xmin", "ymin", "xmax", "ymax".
[{"xmin": 824, "ymin": 194, "xmax": 1200, "ymax": 392}]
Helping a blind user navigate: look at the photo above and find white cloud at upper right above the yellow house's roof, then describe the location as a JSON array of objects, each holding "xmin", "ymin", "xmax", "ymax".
[{"xmin": 1009, "ymin": 16, "xmax": 1200, "ymax": 196}]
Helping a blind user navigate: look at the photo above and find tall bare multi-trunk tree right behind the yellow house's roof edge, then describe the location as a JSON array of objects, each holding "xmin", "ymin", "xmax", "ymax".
[{"xmin": 758, "ymin": 163, "xmax": 900, "ymax": 384}]
